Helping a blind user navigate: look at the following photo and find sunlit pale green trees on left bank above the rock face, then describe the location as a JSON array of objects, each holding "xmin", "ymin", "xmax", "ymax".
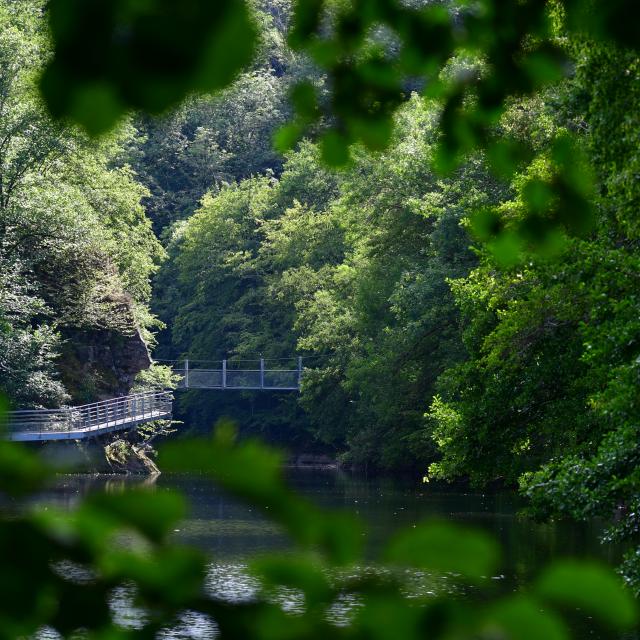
[{"xmin": 0, "ymin": 0, "xmax": 164, "ymax": 406}]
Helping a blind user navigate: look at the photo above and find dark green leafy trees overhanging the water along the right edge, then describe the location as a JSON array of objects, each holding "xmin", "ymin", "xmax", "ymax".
[{"xmin": 427, "ymin": 40, "xmax": 640, "ymax": 592}]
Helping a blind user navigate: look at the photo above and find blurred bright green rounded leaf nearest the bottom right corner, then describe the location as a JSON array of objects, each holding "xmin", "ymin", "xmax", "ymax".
[{"xmin": 534, "ymin": 560, "xmax": 638, "ymax": 628}]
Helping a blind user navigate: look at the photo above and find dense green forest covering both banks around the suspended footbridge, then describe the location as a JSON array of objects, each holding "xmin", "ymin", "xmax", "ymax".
[{"xmin": 0, "ymin": 0, "xmax": 640, "ymax": 586}]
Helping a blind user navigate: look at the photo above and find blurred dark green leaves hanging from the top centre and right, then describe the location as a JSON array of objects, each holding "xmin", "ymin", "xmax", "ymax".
[{"xmin": 289, "ymin": 0, "xmax": 638, "ymax": 250}]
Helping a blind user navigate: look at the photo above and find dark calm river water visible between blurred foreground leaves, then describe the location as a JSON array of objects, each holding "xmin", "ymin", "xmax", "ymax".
[{"xmin": 23, "ymin": 469, "xmax": 632, "ymax": 639}]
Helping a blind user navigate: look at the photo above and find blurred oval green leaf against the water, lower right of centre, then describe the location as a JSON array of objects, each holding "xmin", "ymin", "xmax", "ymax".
[{"xmin": 385, "ymin": 522, "xmax": 500, "ymax": 579}]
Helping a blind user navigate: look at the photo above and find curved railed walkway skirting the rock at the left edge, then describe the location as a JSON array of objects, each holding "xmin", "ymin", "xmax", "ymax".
[{"xmin": 5, "ymin": 391, "xmax": 173, "ymax": 442}]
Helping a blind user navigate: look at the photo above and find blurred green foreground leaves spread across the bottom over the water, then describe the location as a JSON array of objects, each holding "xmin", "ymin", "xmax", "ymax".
[{"xmin": 0, "ymin": 402, "xmax": 637, "ymax": 640}]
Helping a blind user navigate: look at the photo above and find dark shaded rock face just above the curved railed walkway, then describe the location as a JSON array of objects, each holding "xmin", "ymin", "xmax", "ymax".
[{"xmin": 59, "ymin": 328, "xmax": 151, "ymax": 404}]
